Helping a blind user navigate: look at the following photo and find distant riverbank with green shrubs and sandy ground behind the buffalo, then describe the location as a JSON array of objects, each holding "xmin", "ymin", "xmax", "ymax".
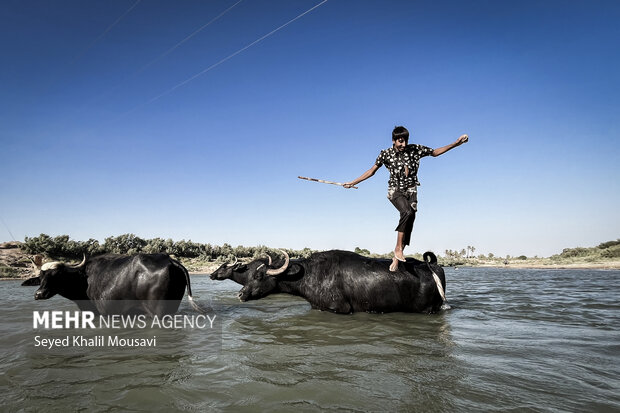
[{"xmin": 18, "ymin": 234, "xmax": 620, "ymax": 272}]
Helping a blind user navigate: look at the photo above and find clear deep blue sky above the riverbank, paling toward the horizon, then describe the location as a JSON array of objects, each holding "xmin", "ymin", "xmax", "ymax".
[{"xmin": 0, "ymin": 0, "xmax": 620, "ymax": 256}]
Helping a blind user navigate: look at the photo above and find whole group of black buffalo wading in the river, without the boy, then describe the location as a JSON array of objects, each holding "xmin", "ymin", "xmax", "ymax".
[{"xmin": 22, "ymin": 250, "xmax": 446, "ymax": 316}]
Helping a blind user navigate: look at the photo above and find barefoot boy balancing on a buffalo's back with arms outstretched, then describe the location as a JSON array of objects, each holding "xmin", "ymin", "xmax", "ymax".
[{"xmin": 343, "ymin": 126, "xmax": 468, "ymax": 271}]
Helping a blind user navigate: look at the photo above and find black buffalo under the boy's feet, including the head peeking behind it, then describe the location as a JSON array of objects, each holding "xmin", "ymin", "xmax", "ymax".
[{"xmin": 211, "ymin": 250, "xmax": 446, "ymax": 314}]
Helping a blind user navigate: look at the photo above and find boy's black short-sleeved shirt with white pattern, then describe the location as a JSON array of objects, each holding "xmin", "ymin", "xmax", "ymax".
[{"xmin": 375, "ymin": 144, "xmax": 433, "ymax": 190}]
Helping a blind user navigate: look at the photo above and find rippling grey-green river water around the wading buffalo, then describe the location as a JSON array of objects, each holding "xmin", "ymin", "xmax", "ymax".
[{"xmin": 0, "ymin": 268, "xmax": 620, "ymax": 412}]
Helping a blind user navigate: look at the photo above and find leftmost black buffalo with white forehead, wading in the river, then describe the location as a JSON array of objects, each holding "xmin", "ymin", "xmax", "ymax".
[{"xmin": 22, "ymin": 254, "xmax": 200, "ymax": 316}]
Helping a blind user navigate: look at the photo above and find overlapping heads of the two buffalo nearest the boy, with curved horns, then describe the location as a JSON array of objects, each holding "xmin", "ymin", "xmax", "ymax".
[{"xmin": 211, "ymin": 251, "xmax": 290, "ymax": 301}]
